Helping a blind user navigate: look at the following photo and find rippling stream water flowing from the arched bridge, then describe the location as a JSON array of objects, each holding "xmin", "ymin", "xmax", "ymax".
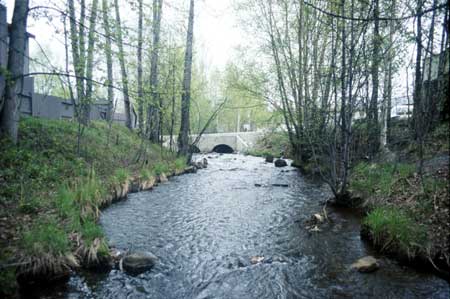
[{"xmin": 43, "ymin": 155, "xmax": 450, "ymax": 299}]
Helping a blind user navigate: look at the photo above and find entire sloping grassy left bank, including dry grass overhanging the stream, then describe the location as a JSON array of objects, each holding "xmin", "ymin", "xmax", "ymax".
[{"xmin": 0, "ymin": 118, "xmax": 186, "ymax": 295}]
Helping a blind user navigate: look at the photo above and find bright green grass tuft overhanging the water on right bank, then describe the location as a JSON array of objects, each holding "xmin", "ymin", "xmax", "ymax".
[{"xmin": 363, "ymin": 207, "xmax": 427, "ymax": 257}]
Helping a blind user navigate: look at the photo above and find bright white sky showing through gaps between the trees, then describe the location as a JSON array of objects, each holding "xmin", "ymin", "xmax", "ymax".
[{"xmin": 0, "ymin": 0, "xmax": 244, "ymax": 71}]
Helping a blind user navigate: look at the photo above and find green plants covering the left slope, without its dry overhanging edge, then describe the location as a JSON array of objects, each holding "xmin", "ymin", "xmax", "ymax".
[{"xmin": 0, "ymin": 117, "xmax": 181, "ymax": 296}]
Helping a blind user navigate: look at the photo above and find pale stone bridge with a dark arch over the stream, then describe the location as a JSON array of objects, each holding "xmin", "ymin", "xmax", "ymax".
[{"xmin": 163, "ymin": 132, "xmax": 264, "ymax": 153}]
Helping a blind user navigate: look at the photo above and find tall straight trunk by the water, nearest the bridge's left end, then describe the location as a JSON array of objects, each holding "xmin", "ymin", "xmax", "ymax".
[{"xmin": 178, "ymin": 0, "xmax": 194, "ymax": 155}]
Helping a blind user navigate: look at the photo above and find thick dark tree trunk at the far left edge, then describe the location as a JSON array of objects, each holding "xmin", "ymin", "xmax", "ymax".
[{"xmin": 0, "ymin": 0, "xmax": 28, "ymax": 143}]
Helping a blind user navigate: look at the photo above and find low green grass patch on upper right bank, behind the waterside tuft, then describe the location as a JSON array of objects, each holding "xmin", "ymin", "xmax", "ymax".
[{"xmin": 350, "ymin": 162, "xmax": 415, "ymax": 197}]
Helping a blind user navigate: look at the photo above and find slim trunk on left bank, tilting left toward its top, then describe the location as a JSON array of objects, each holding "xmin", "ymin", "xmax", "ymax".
[{"xmin": 114, "ymin": 0, "xmax": 133, "ymax": 130}]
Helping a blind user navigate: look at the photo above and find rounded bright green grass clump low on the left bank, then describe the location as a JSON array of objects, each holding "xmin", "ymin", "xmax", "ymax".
[{"xmin": 21, "ymin": 219, "xmax": 70, "ymax": 256}]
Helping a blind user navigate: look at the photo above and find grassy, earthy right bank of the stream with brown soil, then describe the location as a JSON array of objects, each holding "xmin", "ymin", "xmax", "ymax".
[{"xmin": 350, "ymin": 123, "xmax": 450, "ymax": 274}]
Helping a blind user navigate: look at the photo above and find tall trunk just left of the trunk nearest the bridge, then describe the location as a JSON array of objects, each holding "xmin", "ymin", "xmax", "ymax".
[{"xmin": 147, "ymin": 0, "xmax": 163, "ymax": 142}]
